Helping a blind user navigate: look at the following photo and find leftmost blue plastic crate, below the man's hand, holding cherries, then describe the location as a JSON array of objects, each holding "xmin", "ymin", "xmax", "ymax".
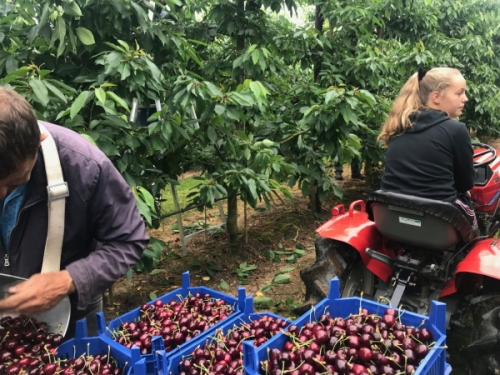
[{"xmin": 56, "ymin": 319, "xmax": 146, "ymax": 375}]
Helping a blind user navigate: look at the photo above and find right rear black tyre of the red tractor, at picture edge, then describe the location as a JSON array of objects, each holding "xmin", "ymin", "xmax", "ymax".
[{"xmin": 462, "ymin": 298, "xmax": 500, "ymax": 375}]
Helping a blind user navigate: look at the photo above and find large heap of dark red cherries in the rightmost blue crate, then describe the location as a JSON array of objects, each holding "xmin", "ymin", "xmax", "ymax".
[{"xmin": 260, "ymin": 308, "xmax": 433, "ymax": 375}]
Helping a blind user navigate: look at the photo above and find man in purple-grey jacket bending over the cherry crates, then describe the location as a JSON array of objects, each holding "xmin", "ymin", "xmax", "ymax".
[{"xmin": 0, "ymin": 88, "xmax": 148, "ymax": 336}]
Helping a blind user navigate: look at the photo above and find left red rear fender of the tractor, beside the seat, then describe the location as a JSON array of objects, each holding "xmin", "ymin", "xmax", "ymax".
[{"xmin": 316, "ymin": 200, "xmax": 393, "ymax": 282}]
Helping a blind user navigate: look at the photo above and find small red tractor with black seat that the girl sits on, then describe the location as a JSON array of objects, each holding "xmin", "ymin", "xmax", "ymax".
[{"xmin": 297, "ymin": 143, "xmax": 500, "ymax": 375}]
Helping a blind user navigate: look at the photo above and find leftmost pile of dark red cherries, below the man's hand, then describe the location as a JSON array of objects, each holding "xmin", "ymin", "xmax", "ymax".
[{"xmin": 0, "ymin": 316, "xmax": 126, "ymax": 375}]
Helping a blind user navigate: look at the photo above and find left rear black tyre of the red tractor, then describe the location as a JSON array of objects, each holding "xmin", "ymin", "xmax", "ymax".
[{"xmin": 294, "ymin": 238, "xmax": 374, "ymax": 315}]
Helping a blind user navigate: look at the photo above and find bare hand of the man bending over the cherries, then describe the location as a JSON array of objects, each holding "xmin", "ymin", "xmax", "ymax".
[{"xmin": 0, "ymin": 270, "xmax": 75, "ymax": 314}]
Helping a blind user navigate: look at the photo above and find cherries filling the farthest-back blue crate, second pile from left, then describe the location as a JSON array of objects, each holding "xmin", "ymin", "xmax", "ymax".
[{"xmin": 112, "ymin": 293, "xmax": 234, "ymax": 354}]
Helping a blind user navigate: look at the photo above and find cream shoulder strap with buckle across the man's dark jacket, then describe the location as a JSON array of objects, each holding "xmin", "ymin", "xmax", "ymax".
[{"xmin": 38, "ymin": 123, "xmax": 69, "ymax": 273}]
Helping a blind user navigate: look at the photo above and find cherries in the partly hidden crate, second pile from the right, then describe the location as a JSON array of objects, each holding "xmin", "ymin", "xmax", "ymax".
[{"xmin": 179, "ymin": 315, "xmax": 288, "ymax": 375}]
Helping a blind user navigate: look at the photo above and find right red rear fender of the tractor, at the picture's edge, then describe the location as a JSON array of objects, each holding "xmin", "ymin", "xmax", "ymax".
[{"xmin": 440, "ymin": 238, "xmax": 500, "ymax": 297}]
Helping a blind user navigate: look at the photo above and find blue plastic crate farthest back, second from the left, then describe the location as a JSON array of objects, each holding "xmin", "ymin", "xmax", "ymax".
[{"xmin": 96, "ymin": 272, "xmax": 246, "ymax": 375}]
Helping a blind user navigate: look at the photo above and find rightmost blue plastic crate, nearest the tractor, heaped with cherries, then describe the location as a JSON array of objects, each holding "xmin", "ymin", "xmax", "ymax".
[{"xmin": 243, "ymin": 278, "xmax": 446, "ymax": 375}]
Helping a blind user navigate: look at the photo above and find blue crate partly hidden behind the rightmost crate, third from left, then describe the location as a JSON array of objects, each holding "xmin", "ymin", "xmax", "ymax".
[{"xmin": 157, "ymin": 297, "xmax": 291, "ymax": 375}]
